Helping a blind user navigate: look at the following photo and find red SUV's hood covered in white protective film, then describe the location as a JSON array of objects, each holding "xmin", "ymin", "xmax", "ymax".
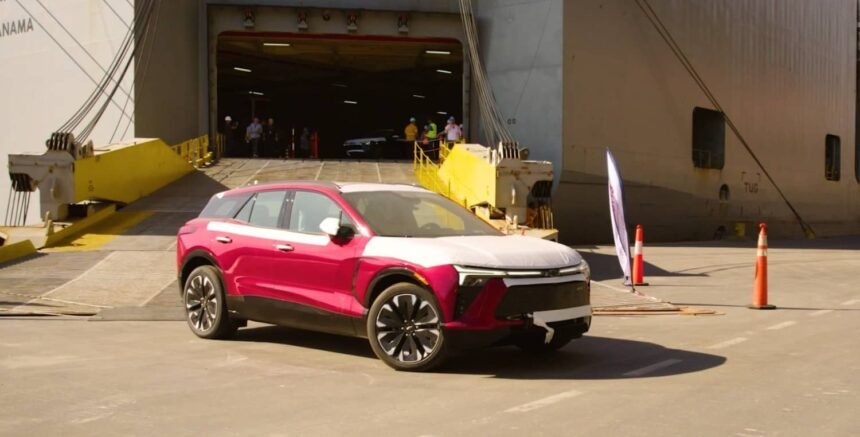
[{"xmin": 363, "ymin": 236, "xmax": 582, "ymax": 269}]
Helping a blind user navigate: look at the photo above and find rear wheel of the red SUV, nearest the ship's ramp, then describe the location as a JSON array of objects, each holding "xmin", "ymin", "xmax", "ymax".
[{"xmin": 182, "ymin": 266, "xmax": 239, "ymax": 339}]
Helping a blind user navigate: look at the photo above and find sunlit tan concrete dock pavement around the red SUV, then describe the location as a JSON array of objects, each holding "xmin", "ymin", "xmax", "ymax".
[{"xmin": 0, "ymin": 233, "xmax": 860, "ymax": 437}]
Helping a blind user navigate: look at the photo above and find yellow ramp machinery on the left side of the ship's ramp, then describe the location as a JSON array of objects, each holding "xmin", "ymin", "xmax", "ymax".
[{"xmin": 0, "ymin": 133, "xmax": 214, "ymax": 252}]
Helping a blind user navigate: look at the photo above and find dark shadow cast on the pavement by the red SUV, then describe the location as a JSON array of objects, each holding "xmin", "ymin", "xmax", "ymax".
[{"xmin": 233, "ymin": 326, "xmax": 726, "ymax": 380}]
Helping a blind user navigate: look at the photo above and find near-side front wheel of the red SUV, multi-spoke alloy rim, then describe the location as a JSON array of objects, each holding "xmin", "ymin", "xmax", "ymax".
[{"xmin": 367, "ymin": 283, "xmax": 448, "ymax": 372}]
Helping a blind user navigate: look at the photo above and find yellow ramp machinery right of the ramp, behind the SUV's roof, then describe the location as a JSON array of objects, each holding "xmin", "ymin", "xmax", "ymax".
[{"xmin": 413, "ymin": 142, "xmax": 558, "ymax": 240}]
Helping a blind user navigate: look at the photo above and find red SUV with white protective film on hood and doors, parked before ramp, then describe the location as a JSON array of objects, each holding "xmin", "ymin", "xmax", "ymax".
[{"xmin": 177, "ymin": 182, "xmax": 591, "ymax": 370}]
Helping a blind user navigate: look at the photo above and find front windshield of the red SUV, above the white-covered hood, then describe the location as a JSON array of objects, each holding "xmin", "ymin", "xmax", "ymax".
[{"xmin": 343, "ymin": 191, "xmax": 501, "ymax": 238}]
